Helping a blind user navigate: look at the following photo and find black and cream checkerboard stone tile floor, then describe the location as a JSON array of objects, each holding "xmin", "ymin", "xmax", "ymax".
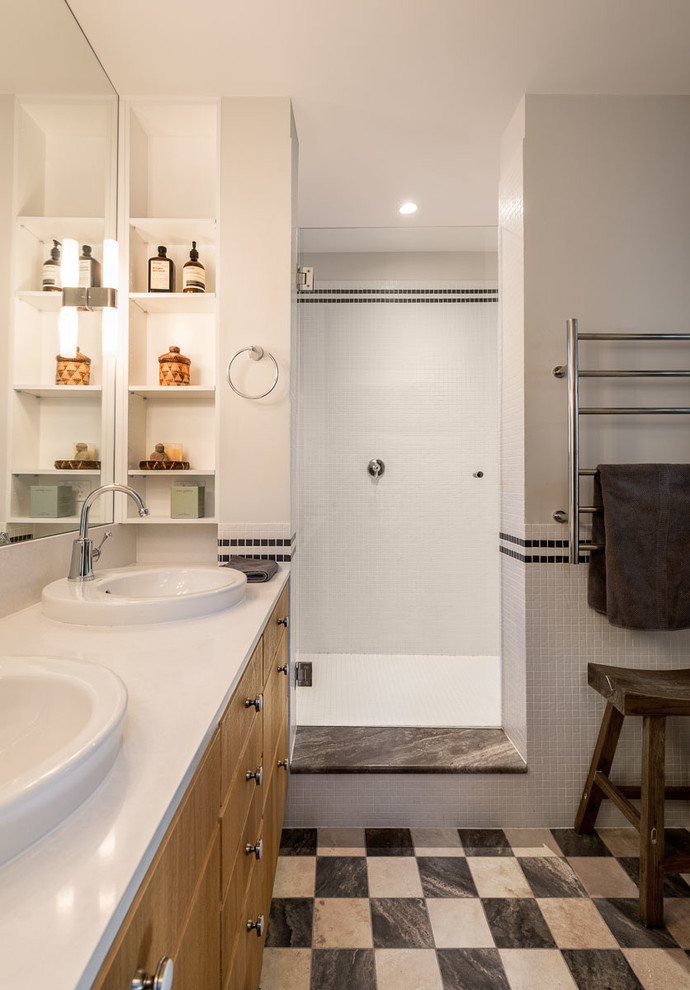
[{"xmin": 261, "ymin": 828, "xmax": 690, "ymax": 990}]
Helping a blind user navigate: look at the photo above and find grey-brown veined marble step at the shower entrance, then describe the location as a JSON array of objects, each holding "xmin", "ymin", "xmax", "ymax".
[{"xmin": 290, "ymin": 725, "xmax": 527, "ymax": 773}]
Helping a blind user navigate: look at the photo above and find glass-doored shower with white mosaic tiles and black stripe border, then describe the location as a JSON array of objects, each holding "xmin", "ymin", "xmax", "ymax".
[{"xmin": 292, "ymin": 228, "xmax": 501, "ymax": 727}]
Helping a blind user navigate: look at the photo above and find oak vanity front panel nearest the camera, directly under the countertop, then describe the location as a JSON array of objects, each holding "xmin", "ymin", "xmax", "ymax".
[{"xmin": 94, "ymin": 733, "xmax": 220, "ymax": 990}]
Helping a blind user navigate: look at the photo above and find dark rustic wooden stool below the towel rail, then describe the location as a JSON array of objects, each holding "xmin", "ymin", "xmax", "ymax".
[{"xmin": 575, "ymin": 663, "xmax": 690, "ymax": 927}]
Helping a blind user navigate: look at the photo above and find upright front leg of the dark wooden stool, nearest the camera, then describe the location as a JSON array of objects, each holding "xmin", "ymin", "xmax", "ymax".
[{"xmin": 640, "ymin": 715, "xmax": 666, "ymax": 928}]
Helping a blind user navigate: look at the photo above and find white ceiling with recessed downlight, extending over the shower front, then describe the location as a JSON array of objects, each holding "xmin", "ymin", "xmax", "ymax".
[{"xmin": 70, "ymin": 0, "xmax": 690, "ymax": 227}]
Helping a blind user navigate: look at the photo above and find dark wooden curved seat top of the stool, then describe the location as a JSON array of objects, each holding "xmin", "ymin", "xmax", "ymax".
[{"xmin": 587, "ymin": 663, "xmax": 690, "ymax": 715}]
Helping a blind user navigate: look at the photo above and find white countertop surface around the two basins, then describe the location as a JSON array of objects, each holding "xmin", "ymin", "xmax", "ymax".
[{"xmin": 0, "ymin": 565, "xmax": 289, "ymax": 990}]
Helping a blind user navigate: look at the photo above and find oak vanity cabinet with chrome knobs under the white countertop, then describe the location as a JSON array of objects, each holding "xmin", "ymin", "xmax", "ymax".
[{"xmin": 93, "ymin": 586, "xmax": 288, "ymax": 990}]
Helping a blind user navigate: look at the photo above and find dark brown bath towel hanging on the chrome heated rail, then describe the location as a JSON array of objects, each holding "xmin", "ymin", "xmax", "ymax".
[{"xmin": 587, "ymin": 464, "xmax": 690, "ymax": 630}]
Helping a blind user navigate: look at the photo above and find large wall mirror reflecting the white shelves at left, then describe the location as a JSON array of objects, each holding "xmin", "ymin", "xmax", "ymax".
[{"xmin": 0, "ymin": 0, "xmax": 118, "ymax": 545}]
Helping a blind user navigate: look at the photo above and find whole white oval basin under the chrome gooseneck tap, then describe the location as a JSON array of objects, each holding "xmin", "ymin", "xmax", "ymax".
[{"xmin": 41, "ymin": 564, "xmax": 247, "ymax": 626}]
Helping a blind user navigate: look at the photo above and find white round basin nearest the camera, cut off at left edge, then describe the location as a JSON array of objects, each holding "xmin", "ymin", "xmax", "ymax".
[{"xmin": 0, "ymin": 657, "xmax": 127, "ymax": 864}]
